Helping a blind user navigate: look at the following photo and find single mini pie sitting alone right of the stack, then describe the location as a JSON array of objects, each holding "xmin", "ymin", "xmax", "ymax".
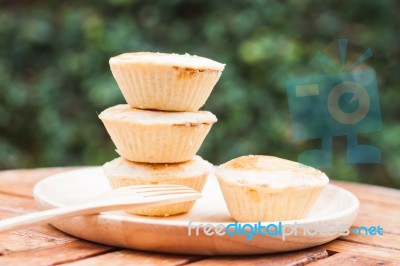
[{"xmin": 216, "ymin": 155, "xmax": 329, "ymax": 222}]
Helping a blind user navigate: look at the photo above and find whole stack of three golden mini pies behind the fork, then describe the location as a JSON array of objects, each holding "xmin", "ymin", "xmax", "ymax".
[{"xmin": 99, "ymin": 53, "xmax": 225, "ymax": 216}]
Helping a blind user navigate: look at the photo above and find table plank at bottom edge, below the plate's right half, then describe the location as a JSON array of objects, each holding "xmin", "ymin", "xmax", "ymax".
[{"xmin": 183, "ymin": 247, "xmax": 328, "ymax": 266}]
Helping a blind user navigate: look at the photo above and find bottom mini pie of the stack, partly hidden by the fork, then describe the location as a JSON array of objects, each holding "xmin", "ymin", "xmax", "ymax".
[{"xmin": 103, "ymin": 155, "xmax": 213, "ymax": 216}]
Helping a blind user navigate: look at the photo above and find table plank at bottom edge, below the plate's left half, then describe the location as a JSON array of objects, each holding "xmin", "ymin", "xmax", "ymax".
[{"xmin": 62, "ymin": 250, "xmax": 202, "ymax": 266}]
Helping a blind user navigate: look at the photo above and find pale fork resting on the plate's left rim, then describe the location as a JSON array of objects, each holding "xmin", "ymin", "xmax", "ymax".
[{"xmin": 0, "ymin": 185, "xmax": 201, "ymax": 233}]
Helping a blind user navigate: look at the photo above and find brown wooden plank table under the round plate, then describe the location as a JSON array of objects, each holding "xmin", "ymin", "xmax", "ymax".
[{"xmin": 0, "ymin": 168, "xmax": 400, "ymax": 266}]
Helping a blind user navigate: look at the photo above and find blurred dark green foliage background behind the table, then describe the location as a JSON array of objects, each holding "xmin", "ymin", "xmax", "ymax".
[{"xmin": 0, "ymin": 0, "xmax": 400, "ymax": 187}]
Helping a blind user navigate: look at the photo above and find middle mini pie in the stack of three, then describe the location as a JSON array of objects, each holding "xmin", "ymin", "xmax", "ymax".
[{"xmin": 99, "ymin": 104, "xmax": 217, "ymax": 163}]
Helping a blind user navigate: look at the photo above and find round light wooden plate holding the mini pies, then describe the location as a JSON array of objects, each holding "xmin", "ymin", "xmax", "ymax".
[{"xmin": 34, "ymin": 167, "xmax": 359, "ymax": 255}]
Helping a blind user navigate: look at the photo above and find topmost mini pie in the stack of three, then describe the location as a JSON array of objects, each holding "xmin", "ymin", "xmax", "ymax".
[{"xmin": 110, "ymin": 52, "xmax": 225, "ymax": 111}]
